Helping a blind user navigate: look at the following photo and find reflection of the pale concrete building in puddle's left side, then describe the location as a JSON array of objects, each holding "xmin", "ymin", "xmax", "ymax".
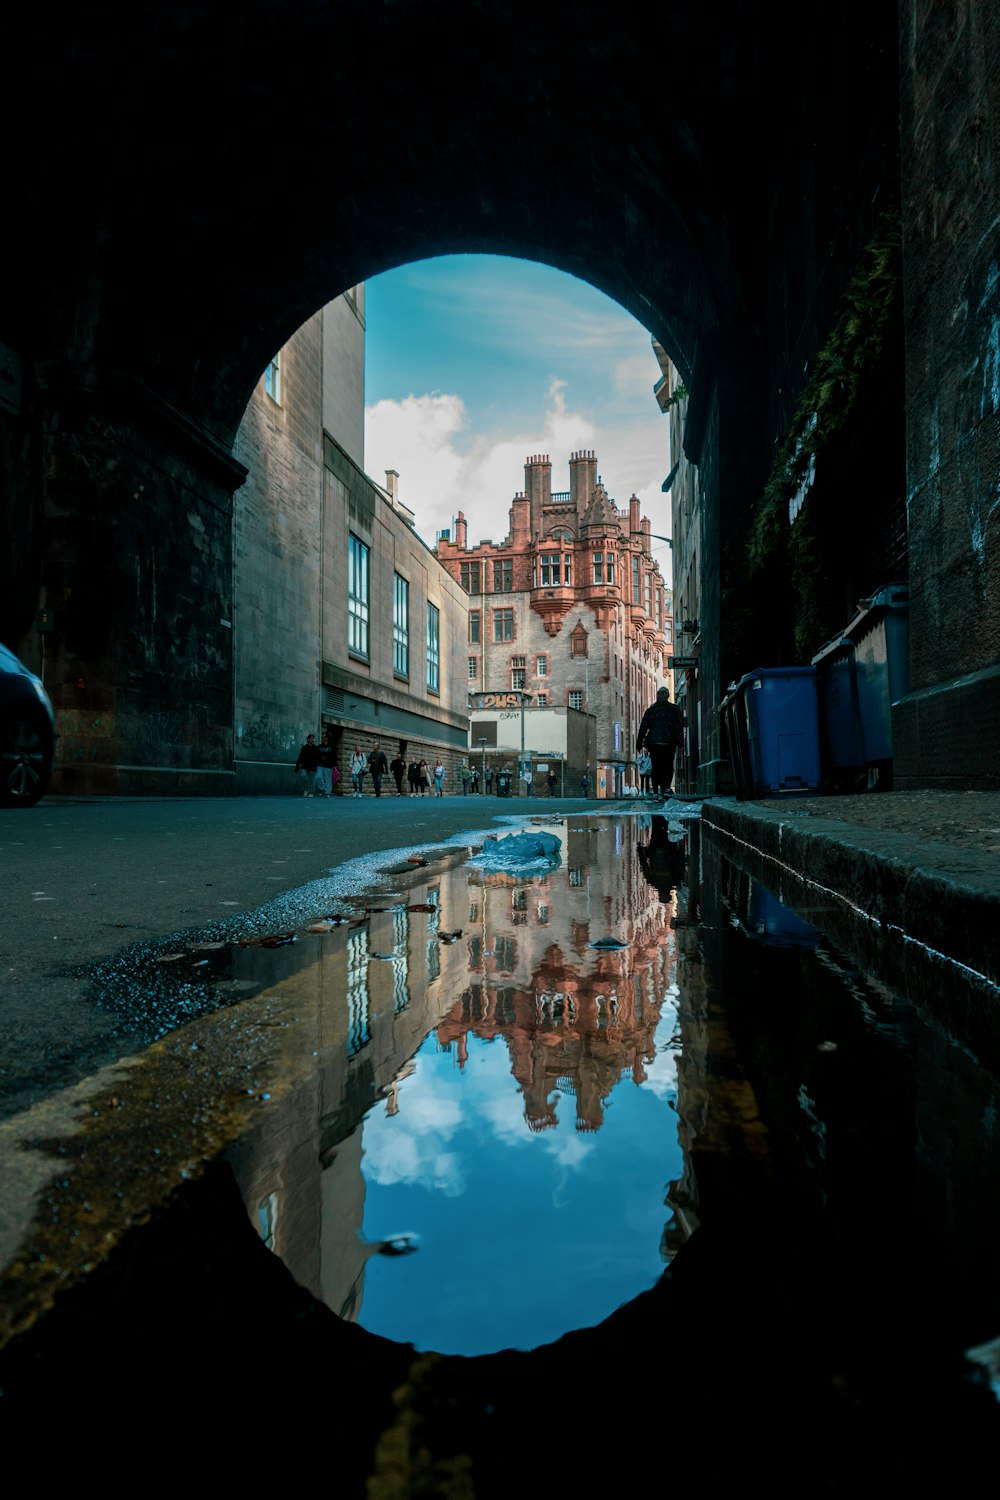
[{"xmin": 229, "ymin": 872, "xmax": 466, "ymax": 1320}]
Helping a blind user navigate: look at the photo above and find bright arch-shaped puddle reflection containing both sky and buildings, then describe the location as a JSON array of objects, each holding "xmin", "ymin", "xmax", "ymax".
[{"xmin": 224, "ymin": 816, "xmax": 684, "ymax": 1355}]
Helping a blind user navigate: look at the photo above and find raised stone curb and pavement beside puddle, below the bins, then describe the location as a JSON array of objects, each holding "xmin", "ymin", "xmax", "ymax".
[{"xmin": 702, "ymin": 798, "xmax": 1000, "ymax": 984}]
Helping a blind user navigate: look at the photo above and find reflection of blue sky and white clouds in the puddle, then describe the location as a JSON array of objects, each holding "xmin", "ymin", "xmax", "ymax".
[{"xmin": 360, "ymin": 1026, "xmax": 682, "ymax": 1355}]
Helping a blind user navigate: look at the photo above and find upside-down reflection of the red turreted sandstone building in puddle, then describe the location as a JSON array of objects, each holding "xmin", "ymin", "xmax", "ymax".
[{"xmin": 436, "ymin": 822, "xmax": 675, "ymax": 1131}]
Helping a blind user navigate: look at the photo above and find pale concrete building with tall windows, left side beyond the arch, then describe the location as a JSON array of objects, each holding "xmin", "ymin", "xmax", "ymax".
[{"xmin": 232, "ymin": 287, "xmax": 468, "ymax": 792}]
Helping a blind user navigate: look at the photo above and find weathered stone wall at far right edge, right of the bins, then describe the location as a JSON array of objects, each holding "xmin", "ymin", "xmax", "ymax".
[{"xmin": 894, "ymin": 0, "xmax": 1000, "ymax": 788}]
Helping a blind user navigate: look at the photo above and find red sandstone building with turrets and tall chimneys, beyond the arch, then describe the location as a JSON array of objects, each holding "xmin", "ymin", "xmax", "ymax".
[{"xmin": 436, "ymin": 452, "xmax": 673, "ymax": 797}]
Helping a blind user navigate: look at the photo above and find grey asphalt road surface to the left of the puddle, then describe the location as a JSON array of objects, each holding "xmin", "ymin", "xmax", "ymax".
[{"xmin": 0, "ymin": 794, "xmax": 598, "ymax": 1118}]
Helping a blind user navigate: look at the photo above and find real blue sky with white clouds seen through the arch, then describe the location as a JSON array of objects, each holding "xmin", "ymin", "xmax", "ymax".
[{"xmin": 364, "ymin": 255, "xmax": 670, "ymax": 573}]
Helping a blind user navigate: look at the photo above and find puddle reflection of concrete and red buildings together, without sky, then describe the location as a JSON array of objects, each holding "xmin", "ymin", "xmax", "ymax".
[{"xmin": 229, "ymin": 819, "xmax": 689, "ymax": 1320}]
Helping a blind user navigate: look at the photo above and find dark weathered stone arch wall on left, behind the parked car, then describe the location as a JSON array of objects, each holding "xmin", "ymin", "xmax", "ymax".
[{"xmin": 36, "ymin": 387, "xmax": 241, "ymax": 795}]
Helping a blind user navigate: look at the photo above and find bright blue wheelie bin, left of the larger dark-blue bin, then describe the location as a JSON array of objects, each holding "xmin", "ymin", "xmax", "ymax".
[{"xmin": 736, "ymin": 666, "xmax": 820, "ymax": 797}]
